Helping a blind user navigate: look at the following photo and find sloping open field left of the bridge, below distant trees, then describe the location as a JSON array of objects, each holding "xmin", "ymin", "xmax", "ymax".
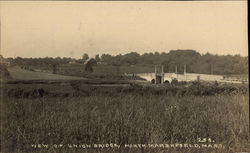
[{"xmin": 5, "ymin": 64, "xmax": 143, "ymax": 83}]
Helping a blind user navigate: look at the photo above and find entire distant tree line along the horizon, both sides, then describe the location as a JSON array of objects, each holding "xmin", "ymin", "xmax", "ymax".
[{"xmin": 2, "ymin": 50, "xmax": 248, "ymax": 74}]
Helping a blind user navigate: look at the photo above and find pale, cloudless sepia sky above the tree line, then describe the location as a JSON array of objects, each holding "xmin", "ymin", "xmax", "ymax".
[{"xmin": 0, "ymin": 1, "xmax": 248, "ymax": 58}]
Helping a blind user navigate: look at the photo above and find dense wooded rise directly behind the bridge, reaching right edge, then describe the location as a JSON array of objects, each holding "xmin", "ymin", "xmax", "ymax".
[{"xmin": 100, "ymin": 50, "xmax": 248, "ymax": 74}]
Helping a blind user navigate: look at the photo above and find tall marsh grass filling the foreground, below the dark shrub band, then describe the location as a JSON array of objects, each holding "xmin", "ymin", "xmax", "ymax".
[{"xmin": 1, "ymin": 89, "xmax": 249, "ymax": 153}]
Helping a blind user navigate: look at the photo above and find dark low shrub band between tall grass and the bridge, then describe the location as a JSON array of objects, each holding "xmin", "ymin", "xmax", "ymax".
[{"xmin": 1, "ymin": 80, "xmax": 248, "ymax": 98}]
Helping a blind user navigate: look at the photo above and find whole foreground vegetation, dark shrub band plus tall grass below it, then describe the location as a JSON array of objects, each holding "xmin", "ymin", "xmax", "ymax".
[{"xmin": 1, "ymin": 81, "xmax": 249, "ymax": 153}]
